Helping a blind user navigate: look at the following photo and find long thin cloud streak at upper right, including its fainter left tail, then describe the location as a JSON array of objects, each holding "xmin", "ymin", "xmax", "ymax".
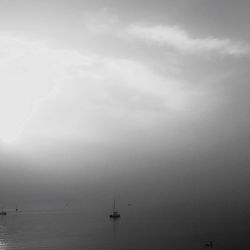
[{"xmin": 81, "ymin": 9, "xmax": 250, "ymax": 56}]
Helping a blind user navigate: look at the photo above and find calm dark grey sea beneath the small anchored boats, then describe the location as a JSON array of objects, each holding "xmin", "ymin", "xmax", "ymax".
[{"xmin": 0, "ymin": 206, "xmax": 250, "ymax": 250}]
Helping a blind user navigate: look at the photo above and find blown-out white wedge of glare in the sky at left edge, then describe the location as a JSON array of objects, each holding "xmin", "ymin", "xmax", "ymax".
[{"xmin": 0, "ymin": 36, "xmax": 98, "ymax": 142}]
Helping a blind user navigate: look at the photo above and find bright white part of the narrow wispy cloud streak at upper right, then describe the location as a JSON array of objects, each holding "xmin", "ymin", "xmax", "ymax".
[{"xmin": 127, "ymin": 24, "xmax": 250, "ymax": 56}]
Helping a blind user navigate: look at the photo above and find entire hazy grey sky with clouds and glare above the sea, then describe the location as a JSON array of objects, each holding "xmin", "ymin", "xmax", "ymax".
[{"xmin": 0, "ymin": 0, "xmax": 250, "ymax": 215}]
